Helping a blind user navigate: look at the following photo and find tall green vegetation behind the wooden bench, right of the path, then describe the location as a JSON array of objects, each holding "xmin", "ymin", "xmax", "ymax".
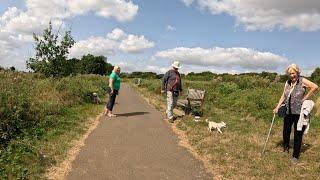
[{"xmin": 139, "ymin": 75, "xmax": 319, "ymax": 122}]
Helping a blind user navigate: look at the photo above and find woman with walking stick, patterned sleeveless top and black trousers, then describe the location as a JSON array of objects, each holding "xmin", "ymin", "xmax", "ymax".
[{"xmin": 273, "ymin": 64, "xmax": 318, "ymax": 163}]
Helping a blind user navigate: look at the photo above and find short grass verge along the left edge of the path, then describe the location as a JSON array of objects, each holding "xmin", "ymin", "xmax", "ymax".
[{"xmin": 0, "ymin": 103, "xmax": 103, "ymax": 179}]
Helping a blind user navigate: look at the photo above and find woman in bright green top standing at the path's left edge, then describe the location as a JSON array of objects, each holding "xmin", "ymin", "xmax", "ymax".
[{"xmin": 105, "ymin": 66, "xmax": 121, "ymax": 117}]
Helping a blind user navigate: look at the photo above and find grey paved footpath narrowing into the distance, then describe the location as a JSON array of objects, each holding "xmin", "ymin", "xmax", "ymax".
[{"xmin": 66, "ymin": 84, "xmax": 213, "ymax": 180}]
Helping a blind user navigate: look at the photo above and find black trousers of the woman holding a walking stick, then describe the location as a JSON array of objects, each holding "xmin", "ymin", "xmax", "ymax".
[{"xmin": 283, "ymin": 114, "xmax": 306, "ymax": 159}]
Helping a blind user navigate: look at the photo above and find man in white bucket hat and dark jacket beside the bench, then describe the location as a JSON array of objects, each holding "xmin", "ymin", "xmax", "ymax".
[{"xmin": 161, "ymin": 61, "xmax": 182, "ymax": 123}]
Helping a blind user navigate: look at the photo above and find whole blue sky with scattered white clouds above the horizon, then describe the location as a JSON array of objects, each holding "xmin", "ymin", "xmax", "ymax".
[{"xmin": 0, "ymin": 0, "xmax": 320, "ymax": 75}]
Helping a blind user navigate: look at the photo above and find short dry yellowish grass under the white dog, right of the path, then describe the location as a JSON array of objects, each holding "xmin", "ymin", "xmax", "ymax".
[{"xmin": 127, "ymin": 79, "xmax": 320, "ymax": 179}]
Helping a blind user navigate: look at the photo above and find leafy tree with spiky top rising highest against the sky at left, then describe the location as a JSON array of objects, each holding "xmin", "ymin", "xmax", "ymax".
[{"xmin": 27, "ymin": 22, "xmax": 75, "ymax": 77}]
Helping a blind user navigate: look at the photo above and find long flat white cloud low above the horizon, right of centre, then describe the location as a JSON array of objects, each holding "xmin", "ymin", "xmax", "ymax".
[{"xmin": 155, "ymin": 47, "xmax": 289, "ymax": 70}]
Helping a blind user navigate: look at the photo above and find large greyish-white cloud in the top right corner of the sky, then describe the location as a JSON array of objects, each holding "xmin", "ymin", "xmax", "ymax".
[{"xmin": 182, "ymin": 0, "xmax": 320, "ymax": 31}]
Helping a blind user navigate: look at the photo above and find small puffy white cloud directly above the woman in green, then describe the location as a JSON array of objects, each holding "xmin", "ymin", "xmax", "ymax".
[{"xmin": 119, "ymin": 34, "xmax": 154, "ymax": 53}]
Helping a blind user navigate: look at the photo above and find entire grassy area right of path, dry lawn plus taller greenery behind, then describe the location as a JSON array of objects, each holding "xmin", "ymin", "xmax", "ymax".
[{"xmin": 129, "ymin": 78, "xmax": 320, "ymax": 179}]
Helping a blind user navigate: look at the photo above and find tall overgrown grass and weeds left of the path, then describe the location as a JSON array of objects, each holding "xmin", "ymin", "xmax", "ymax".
[{"xmin": 0, "ymin": 71, "xmax": 107, "ymax": 179}]
